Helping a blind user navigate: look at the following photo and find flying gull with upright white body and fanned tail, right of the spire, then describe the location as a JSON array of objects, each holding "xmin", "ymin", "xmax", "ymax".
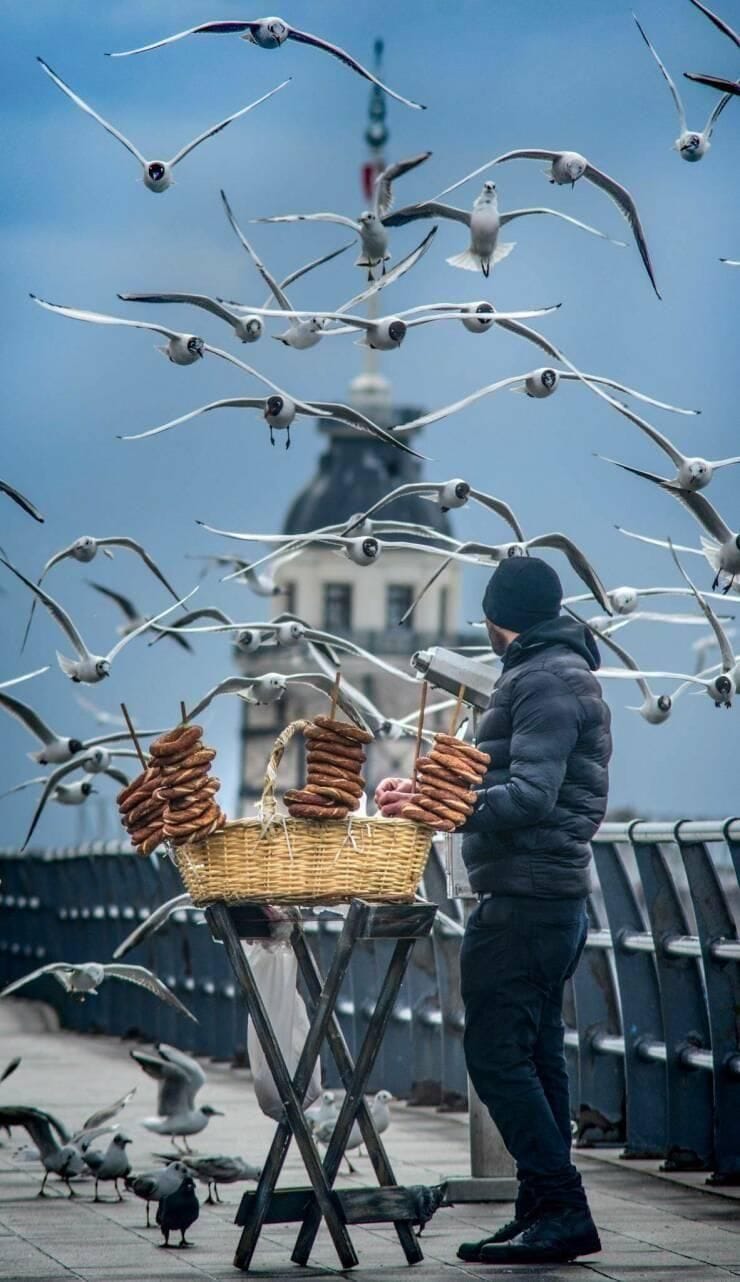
[{"xmin": 383, "ymin": 182, "xmax": 623, "ymax": 277}]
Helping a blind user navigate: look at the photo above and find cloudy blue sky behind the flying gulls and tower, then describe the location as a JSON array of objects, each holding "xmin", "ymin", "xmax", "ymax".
[{"xmin": 0, "ymin": 0, "xmax": 740, "ymax": 844}]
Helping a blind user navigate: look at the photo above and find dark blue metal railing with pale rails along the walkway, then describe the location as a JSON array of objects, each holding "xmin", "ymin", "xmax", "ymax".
[{"xmin": 0, "ymin": 819, "xmax": 740, "ymax": 1182}]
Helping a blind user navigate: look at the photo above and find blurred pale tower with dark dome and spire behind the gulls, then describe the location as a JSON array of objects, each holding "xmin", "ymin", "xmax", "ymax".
[{"xmin": 237, "ymin": 40, "xmax": 472, "ymax": 813}]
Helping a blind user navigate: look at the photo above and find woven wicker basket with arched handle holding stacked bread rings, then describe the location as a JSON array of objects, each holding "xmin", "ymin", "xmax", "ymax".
[{"xmin": 174, "ymin": 720, "xmax": 433, "ymax": 905}]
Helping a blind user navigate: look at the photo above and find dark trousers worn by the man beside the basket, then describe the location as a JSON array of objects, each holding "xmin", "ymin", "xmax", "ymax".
[{"xmin": 460, "ymin": 895, "xmax": 587, "ymax": 1215}]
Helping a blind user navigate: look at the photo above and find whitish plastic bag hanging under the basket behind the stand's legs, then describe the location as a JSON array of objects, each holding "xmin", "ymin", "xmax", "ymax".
[{"xmin": 242, "ymin": 941, "xmax": 321, "ymax": 1122}]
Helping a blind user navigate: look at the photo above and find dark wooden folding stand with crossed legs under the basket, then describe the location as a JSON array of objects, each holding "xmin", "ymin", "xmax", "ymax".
[{"xmin": 206, "ymin": 899, "xmax": 436, "ymax": 1270}]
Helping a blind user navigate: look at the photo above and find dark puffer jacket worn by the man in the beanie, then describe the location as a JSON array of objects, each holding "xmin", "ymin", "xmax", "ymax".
[{"xmin": 463, "ymin": 617, "xmax": 612, "ymax": 899}]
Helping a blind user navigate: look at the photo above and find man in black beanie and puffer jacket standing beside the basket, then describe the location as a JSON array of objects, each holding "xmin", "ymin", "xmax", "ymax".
[{"xmin": 376, "ymin": 556, "xmax": 612, "ymax": 1264}]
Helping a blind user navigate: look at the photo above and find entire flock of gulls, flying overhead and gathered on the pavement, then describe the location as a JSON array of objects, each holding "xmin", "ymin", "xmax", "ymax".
[{"xmin": 0, "ymin": 0, "xmax": 740, "ymax": 1245}]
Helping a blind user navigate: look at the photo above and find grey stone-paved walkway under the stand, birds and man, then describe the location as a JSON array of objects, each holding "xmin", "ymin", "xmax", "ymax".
[{"xmin": 0, "ymin": 1001, "xmax": 740, "ymax": 1282}]
